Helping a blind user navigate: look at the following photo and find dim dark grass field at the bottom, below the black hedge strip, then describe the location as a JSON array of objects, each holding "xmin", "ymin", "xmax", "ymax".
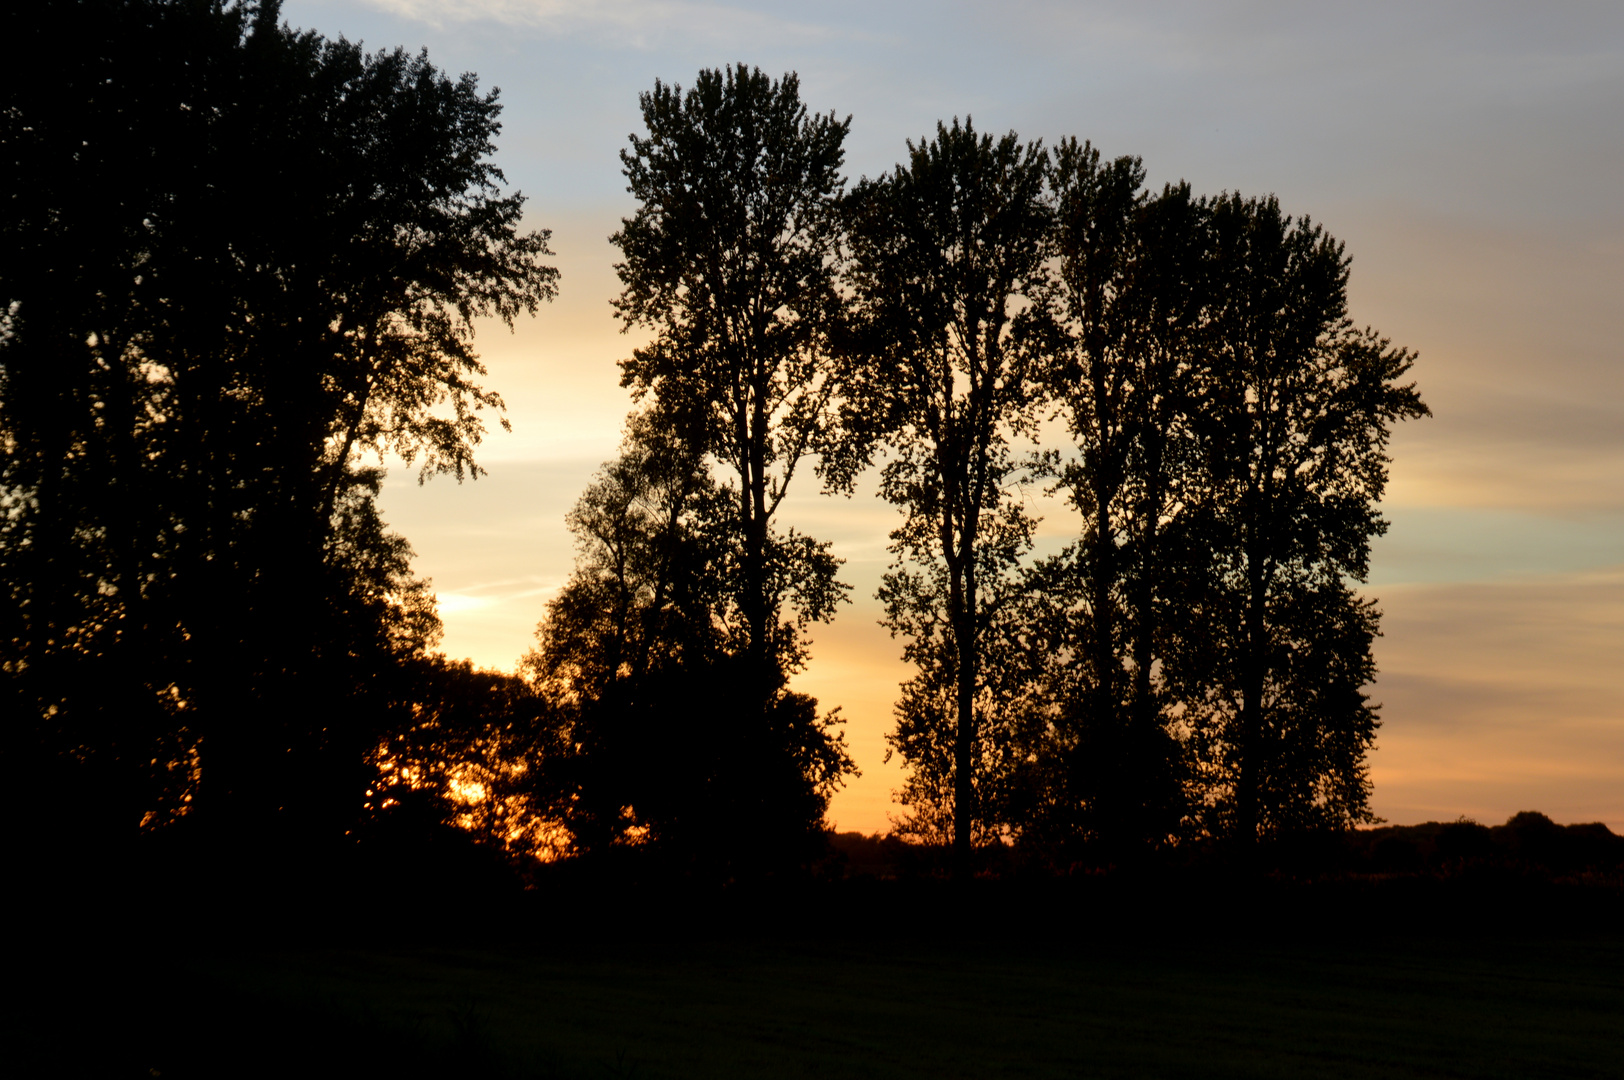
[{"xmin": 25, "ymin": 915, "xmax": 1624, "ymax": 1078}]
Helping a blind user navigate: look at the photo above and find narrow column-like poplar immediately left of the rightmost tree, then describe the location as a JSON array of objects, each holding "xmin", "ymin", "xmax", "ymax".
[{"xmin": 1044, "ymin": 140, "xmax": 1210, "ymax": 858}]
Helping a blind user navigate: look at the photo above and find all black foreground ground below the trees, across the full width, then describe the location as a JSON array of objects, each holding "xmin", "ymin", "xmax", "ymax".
[{"xmin": 12, "ymin": 890, "xmax": 1624, "ymax": 1080}]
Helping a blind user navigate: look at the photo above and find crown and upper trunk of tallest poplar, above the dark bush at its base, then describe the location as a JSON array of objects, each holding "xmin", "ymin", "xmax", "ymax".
[{"xmin": 611, "ymin": 65, "xmax": 851, "ymax": 702}]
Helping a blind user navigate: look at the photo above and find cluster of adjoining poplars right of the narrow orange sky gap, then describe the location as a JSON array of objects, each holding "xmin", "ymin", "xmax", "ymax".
[{"xmin": 846, "ymin": 123, "xmax": 1426, "ymax": 861}]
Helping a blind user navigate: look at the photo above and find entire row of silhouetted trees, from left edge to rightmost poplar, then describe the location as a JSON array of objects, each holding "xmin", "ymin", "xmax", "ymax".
[{"xmin": 0, "ymin": 0, "xmax": 1426, "ymax": 874}]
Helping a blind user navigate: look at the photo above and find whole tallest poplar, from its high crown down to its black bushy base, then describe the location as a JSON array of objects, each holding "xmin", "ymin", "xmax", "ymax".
[{"xmin": 591, "ymin": 65, "xmax": 851, "ymax": 870}]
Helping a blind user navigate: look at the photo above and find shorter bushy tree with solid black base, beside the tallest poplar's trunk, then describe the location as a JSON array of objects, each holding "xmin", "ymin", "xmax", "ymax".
[{"xmin": 525, "ymin": 413, "xmax": 853, "ymax": 872}]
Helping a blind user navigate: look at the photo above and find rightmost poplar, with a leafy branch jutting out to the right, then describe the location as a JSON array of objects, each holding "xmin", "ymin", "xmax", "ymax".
[{"xmin": 1169, "ymin": 195, "xmax": 1429, "ymax": 846}]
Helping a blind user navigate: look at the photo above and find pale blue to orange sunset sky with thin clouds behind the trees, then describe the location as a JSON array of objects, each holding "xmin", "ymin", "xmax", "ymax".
[{"xmin": 283, "ymin": 0, "xmax": 1624, "ymax": 832}]
